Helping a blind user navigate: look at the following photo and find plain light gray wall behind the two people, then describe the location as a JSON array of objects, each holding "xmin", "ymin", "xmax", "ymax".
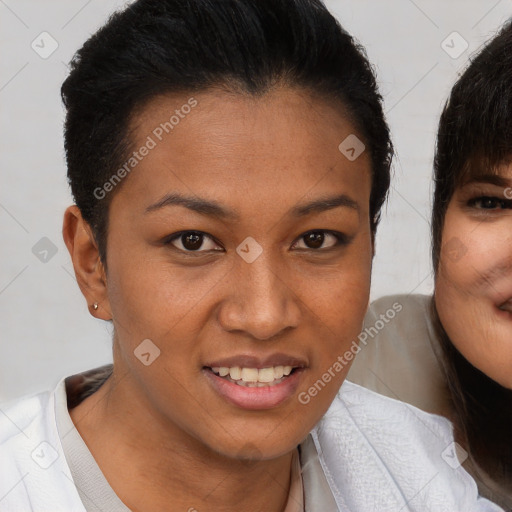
[{"xmin": 0, "ymin": 0, "xmax": 512, "ymax": 401}]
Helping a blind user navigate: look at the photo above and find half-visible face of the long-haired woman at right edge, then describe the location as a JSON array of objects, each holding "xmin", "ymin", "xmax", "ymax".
[{"xmin": 435, "ymin": 165, "xmax": 512, "ymax": 389}]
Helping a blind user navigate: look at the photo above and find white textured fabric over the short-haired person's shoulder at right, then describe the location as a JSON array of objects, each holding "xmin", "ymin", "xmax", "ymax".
[{"xmin": 312, "ymin": 382, "xmax": 501, "ymax": 512}]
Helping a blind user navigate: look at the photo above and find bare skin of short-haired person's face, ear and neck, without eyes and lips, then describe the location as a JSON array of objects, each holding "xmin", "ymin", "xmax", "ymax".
[{"xmin": 63, "ymin": 86, "xmax": 373, "ymax": 512}]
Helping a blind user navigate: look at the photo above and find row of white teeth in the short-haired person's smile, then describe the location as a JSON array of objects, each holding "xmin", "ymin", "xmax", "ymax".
[{"xmin": 206, "ymin": 366, "xmax": 299, "ymax": 388}]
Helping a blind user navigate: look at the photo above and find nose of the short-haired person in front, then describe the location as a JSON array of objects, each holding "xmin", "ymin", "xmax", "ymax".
[{"xmin": 218, "ymin": 255, "xmax": 301, "ymax": 340}]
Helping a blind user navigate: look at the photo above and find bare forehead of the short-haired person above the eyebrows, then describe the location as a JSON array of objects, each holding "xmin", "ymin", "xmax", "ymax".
[{"xmin": 114, "ymin": 87, "xmax": 371, "ymax": 215}]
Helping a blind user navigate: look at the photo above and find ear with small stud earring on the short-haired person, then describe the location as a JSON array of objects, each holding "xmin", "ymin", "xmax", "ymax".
[{"xmin": 62, "ymin": 205, "xmax": 112, "ymax": 320}]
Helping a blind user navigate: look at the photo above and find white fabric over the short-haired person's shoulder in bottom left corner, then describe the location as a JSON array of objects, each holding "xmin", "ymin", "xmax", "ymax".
[{"xmin": 0, "ymin": 380, "xmax": 85, "ymax": 512}]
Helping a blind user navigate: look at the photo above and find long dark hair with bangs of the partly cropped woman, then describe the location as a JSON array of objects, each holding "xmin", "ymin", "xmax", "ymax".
[{"xmin": 431, "ymin": 22, "xmax": 512, "ymax": 488}]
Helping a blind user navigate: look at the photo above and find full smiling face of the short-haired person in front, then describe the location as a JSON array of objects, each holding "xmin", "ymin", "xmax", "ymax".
[{"xmin": 101, "ymin": 88, "xmax": 372, "ymax": 458}]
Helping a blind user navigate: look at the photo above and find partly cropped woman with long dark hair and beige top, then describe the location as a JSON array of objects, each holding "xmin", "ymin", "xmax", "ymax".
[{"xmin": 349, "ymin": 20, "xmax": 512, "ymax": 510}]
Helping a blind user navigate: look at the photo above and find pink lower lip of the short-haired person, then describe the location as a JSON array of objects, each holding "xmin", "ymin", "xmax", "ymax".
[{"xmin": 203, "ymin": 366, "xmax": 304, "ymax": 411}]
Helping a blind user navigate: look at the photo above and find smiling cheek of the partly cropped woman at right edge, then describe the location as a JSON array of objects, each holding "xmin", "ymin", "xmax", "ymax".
[{"xmin": 435, "ymin": 210, "xmax": 512, "ymax": 378}]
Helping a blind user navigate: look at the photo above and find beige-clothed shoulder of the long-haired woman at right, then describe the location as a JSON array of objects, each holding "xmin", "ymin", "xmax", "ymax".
[{"xmin": 348, "ymin": 295, "xmax": 450, "ymax": 414}]
